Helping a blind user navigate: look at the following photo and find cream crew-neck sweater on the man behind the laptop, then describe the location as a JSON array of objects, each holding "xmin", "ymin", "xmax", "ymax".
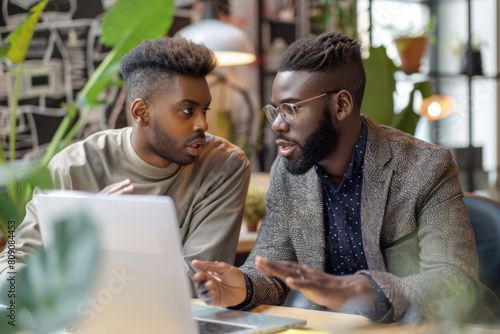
[{"xmin": 0, "ymin": 127, "xmax": 250, "ymax": 292}]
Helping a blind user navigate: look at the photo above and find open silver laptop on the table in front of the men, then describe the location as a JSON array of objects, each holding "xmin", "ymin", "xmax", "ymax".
[{"xmin": 35, "ymin": 191, "xmax": 305, "ymax": 334}]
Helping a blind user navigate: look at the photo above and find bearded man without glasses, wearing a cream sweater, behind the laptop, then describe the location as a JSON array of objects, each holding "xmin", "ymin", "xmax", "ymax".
[{"xmin": 0, "ymin": 37, "xmax": 250, "ymax": 294}]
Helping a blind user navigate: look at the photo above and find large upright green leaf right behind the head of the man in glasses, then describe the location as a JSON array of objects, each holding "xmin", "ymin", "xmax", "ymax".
[{"xmin": 361, "ymin": 46, "xmax": 398, "ymax": 125}]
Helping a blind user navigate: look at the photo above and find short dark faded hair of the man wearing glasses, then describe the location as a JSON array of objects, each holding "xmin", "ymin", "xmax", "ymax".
[{"xmin": 278, "ymin": 32, "xmax": 366, "ymax": 110}]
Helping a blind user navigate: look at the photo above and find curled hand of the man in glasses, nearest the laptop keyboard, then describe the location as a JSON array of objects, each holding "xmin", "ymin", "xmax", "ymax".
[{"xmin": 191, "ymin": 260, "xmax": 247, "ymax": 307}]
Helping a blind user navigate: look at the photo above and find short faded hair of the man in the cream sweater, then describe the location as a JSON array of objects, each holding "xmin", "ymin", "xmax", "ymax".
[{"xmin": 120, "ymin": 37, "xmax": 217, "ymax": 106}]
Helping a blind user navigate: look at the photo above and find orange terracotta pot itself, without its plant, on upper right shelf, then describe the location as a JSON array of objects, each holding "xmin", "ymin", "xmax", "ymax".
[{"xmin": 394, "ymin": 36, "xmax": 429, "ymax": 74}]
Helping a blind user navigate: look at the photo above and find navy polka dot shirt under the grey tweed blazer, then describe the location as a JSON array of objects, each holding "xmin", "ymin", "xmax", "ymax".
[{"xmin": 315, "ymin": 122, "xmax": 392, "ymax": 320}]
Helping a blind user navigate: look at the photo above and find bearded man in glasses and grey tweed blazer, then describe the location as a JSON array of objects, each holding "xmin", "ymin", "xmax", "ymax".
[{"xmin": 192, "ymin": 33, "xmax": 494, "ymax": 322}]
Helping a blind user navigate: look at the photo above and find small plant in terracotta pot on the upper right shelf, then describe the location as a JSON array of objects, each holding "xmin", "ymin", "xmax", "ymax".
[{"xmin": 387, "ymin": 16, "xmax": 436, "ymax": 74}]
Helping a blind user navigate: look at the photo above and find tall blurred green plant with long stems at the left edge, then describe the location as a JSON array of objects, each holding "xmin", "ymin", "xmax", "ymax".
[{"xmin": 0, "ymin": 0, "xmax": 175, "ymax": 236}]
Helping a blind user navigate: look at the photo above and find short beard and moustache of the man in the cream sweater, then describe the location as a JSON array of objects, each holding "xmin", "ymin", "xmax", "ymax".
[{"xmin": 149, "ymin": 119, "xmax": 205, "ymax": 166}]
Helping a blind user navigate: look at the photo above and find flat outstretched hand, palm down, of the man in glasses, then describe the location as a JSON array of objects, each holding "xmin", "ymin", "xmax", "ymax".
[{"xmin": 255, "ymin": 256, "xmax": 375, "ymax": 312}]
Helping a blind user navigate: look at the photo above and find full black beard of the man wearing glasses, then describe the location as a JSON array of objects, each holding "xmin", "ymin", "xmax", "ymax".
[{"xmin": 277, "ymin": 108, "xmax": 336, "ymax": 175}]
